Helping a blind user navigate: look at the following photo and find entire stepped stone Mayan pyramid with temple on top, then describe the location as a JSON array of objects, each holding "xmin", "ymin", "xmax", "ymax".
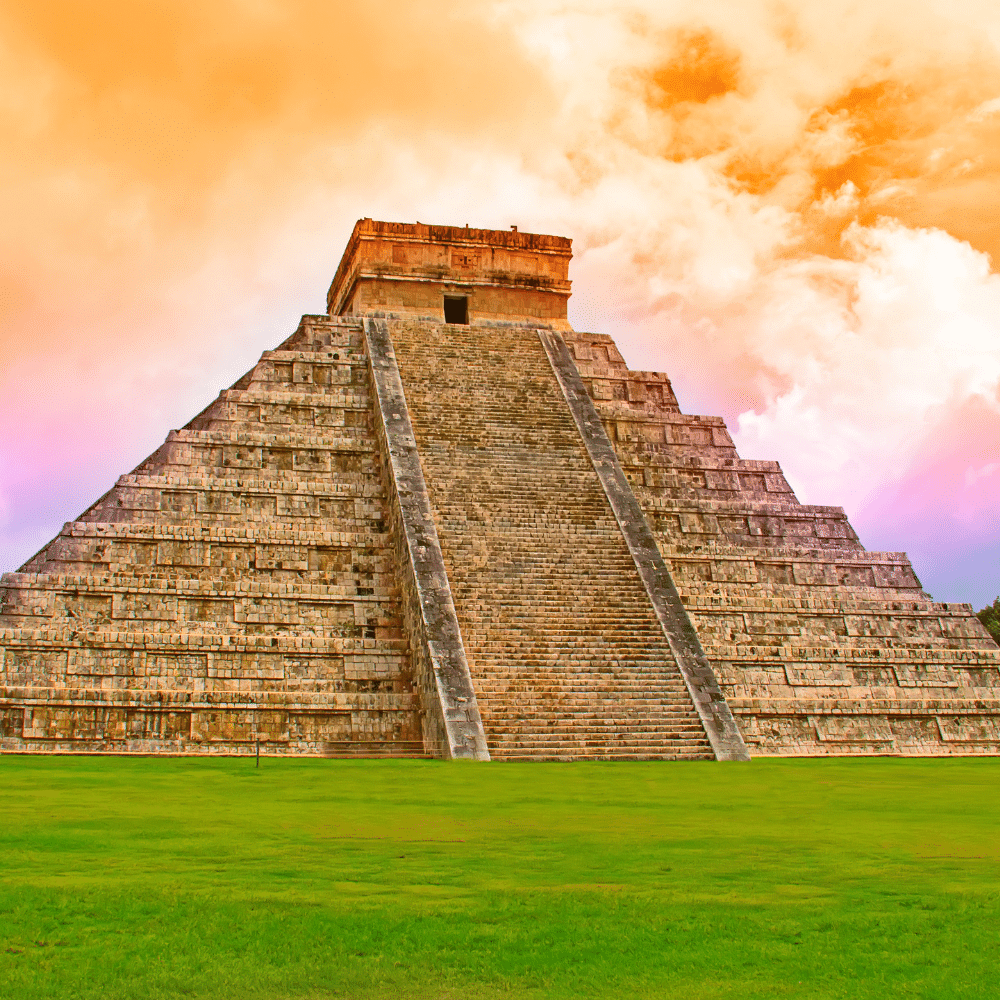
[{"xmin": 0, "ymin": 219, "xmax": 1000, "ymax": 760}]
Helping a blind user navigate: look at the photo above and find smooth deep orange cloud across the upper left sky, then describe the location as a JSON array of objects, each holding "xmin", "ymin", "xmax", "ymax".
[{"xmin": 2, "ymin": 0, "xmax": 542, "ymax": 193}]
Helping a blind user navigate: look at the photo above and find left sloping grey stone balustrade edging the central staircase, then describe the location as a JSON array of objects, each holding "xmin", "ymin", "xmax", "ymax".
[{"xmin": 364, "ymin": 319, "xmax": 490, "ymax": 760}]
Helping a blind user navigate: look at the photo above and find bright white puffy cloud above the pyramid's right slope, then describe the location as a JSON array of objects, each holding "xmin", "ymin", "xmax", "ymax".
[{"xmin": 737, "ymin": 221, "xmax": 1000, "ymax": 498}]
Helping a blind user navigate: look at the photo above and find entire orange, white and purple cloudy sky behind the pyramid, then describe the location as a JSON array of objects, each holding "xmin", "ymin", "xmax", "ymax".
[{"xmin": 0, "ymin": 0, "xmax": 1000, "ymax": 608}]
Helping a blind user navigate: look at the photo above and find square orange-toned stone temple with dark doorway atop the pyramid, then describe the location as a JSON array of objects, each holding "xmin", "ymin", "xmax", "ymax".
[{"xmin": 326, "ymin": 219, "xmax": 573, "ymax": 329}]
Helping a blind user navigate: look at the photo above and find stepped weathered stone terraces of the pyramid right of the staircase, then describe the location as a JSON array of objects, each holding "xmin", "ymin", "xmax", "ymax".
[{"xmin": 565, "ymin": 333, "xmax": 1000, "ymax": 755}]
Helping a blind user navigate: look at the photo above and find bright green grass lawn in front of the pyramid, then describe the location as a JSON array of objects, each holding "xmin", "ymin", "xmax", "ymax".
[{"xmin": 0, "ymin": 756, "xmax": 1000, "ymax": 1000}]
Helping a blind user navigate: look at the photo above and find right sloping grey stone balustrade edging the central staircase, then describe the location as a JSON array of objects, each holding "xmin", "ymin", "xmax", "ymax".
[{"xmin": 538, "ymin": 330, "xmax": 750, "ymax": 760}]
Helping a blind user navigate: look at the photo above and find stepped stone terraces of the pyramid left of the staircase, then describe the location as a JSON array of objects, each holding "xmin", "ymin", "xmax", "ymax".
[{"xmin": 0, "ymin": 317, "xmax": 424, "ymax": 756}]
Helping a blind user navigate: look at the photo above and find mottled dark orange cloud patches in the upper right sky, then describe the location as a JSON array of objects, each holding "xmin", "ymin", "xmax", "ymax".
[{"xmin": 609, "ymin": 4, "xmax": 1000, "ymax": 259}]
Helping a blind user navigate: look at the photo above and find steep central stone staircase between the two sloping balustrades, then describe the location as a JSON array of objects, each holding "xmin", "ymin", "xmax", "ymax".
[{"xmin": 389, "ymin": 320, "xmax": 713, "ymax": 760}]
